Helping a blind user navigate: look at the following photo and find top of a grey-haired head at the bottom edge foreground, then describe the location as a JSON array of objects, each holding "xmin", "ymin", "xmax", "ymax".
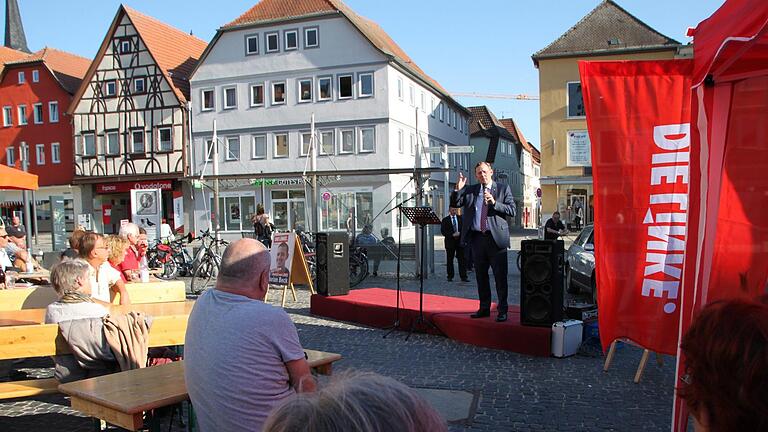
[{"xmin": 264, "ymin": 372, "xmax": 448, "ymax": 432}]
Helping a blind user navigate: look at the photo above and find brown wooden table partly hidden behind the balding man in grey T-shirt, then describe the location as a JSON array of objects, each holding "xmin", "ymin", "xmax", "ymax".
[{"xmin": 59, "ymin": 350, "xmax": 341, "ymax": 431}]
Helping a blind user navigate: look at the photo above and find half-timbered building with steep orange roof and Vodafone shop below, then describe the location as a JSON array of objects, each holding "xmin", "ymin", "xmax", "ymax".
[{"xmin": 69, "ymin": 6, "xmax": 207, "ymax": 233}]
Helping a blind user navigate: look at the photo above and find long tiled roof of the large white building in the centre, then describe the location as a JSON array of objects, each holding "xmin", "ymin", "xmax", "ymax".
[{"xmin": 216, "ymin": 0, "xmax": 469, "ymax": 114}]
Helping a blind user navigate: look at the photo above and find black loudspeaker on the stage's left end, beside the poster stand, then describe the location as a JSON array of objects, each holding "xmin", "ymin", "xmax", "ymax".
[{"xmin": 315, "ymin": 232, "xmax": 349, "ymax": 296}]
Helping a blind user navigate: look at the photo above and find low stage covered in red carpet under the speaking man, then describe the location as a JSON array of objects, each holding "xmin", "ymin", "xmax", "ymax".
[{"xmin": 310, "ymin": 288, "xmax": 551, "ymax": 357}]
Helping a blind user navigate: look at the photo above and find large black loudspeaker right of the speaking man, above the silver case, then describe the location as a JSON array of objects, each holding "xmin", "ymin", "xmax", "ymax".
[{"xmin": 520, "ymin": 240, "xmax": 565, "ymax": 327}]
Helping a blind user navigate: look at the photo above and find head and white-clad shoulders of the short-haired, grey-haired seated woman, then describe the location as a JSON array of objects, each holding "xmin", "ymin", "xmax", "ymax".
[{"xmin": 45, "ymin": 258, "xmax": 108, "ymax": 324}]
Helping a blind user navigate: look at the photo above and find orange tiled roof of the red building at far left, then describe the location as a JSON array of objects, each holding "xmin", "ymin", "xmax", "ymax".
[{"xmin": 6, "ymin": 47, "xmax": 91, "ymax": 94}]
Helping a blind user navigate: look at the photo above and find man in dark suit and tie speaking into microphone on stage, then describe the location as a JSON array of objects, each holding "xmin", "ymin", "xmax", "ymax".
[{"xmin": 451, "ymin": 162, "xmax": 515, "ymax": 322}]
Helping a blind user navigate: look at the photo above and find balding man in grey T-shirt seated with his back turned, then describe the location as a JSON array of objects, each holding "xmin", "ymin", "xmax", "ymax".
[{"xmin": 184, "ymin": 239, "xmax": 315, "ymax": 432}]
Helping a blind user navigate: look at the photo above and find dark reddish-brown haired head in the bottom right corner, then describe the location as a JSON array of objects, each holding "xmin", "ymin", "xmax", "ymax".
[{"xmin": 678, "ymin": 296, "xmax": 768, "ymax": 432}]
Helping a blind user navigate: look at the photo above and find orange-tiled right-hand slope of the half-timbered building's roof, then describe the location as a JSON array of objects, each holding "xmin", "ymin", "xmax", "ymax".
[{"xmin": 122, "ymin": 6, "xmax": 208, "ymax": 103}]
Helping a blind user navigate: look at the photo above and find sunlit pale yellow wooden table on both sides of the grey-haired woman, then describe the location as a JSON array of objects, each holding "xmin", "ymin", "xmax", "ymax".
[{"xmin": 0, "ymin": 281, "xmax": 187, "ymax": 311}]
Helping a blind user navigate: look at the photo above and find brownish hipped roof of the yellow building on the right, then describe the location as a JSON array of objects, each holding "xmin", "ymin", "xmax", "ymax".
[{"xmin": 532, "ymin": 0, "xmax": 680, "ymax": 66}]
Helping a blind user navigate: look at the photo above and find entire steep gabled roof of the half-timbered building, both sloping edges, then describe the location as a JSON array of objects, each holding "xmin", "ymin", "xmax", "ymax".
[{"xmin": 70, "ymin": 5, "xmax": 208, "ymax": 110}]
